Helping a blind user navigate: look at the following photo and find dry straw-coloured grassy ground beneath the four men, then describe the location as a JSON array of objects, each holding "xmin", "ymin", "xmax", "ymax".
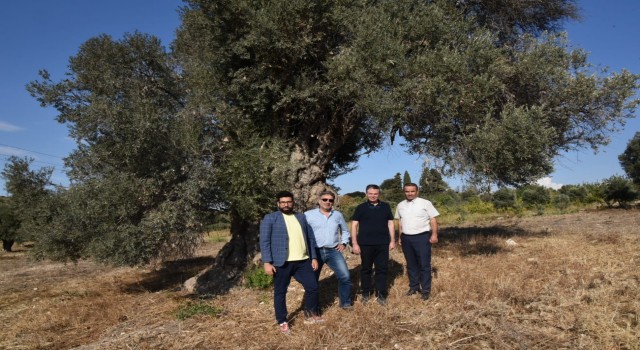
[{"xmin": 0, "ymin": 210, "xmax": 640, "ymax": 349}]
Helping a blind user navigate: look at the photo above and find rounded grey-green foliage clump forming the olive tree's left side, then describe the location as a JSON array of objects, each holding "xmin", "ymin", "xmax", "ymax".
[{"xmin": 29, "ymin": 33, "xmax": 225, "ymax": 265}]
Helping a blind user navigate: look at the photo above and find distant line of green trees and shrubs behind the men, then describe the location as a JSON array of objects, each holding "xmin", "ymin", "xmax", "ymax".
[{"xmin": 339, "ymin": 163, "xmax": 640, "ymax": 220}]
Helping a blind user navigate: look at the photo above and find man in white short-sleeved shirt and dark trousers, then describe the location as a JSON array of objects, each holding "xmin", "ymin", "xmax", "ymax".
[{"xmin": 395, "ymin": 183, "xmax": 440, "ymax": 300}]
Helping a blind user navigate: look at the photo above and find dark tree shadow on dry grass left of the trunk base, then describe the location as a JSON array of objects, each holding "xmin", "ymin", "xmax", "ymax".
[{"xmin": 122, "ymin": 256, "xmax": 215, "ymax": 293}]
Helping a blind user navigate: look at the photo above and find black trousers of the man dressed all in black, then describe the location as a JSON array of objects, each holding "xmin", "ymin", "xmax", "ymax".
[{"xmin": 360, "ymin": 244, "xmax": 389, "ymax": 298}]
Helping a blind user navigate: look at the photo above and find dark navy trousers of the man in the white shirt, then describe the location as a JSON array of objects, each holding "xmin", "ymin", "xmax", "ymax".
[{"xmin": 402, "ymin": 232, "xmax": 431, "ymax": 294}]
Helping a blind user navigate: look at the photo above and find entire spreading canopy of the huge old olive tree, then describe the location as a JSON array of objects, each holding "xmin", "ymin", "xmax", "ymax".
[{"xmin": 18, "ymin": 0, "xmax": 639, "ymax": 282}]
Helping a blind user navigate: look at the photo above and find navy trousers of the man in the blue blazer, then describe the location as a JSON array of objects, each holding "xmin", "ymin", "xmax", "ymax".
[{"xmin": 273, "ymin": 259, "xmax": 318, "ymax": 324}]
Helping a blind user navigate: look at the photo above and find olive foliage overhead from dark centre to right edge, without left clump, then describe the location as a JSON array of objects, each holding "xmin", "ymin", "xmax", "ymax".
[{"xmin": 176, "ymin": 0, "xmax": 638, "ymax": 191}]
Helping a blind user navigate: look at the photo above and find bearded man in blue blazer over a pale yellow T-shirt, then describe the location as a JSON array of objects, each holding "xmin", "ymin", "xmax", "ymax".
[{"xmin": 260, "ymin": 191, "xmax": 324, "ymax": 333}]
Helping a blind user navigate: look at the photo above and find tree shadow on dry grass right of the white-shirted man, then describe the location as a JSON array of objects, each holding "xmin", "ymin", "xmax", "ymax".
[{"xmin": 438, "ymin": 225, "xmax": 548, "ymax": 256}]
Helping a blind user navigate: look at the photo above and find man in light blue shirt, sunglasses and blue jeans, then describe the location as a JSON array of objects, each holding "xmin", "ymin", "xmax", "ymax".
[{"xmin": 304, "ymin": 191, "xmax": 351, "ymax": 310}]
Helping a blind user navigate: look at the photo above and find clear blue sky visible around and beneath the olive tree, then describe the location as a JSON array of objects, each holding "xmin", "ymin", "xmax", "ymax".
[{"xmin": 0, "ymin": 0, "xmax": 640, "ymax": 195}]
